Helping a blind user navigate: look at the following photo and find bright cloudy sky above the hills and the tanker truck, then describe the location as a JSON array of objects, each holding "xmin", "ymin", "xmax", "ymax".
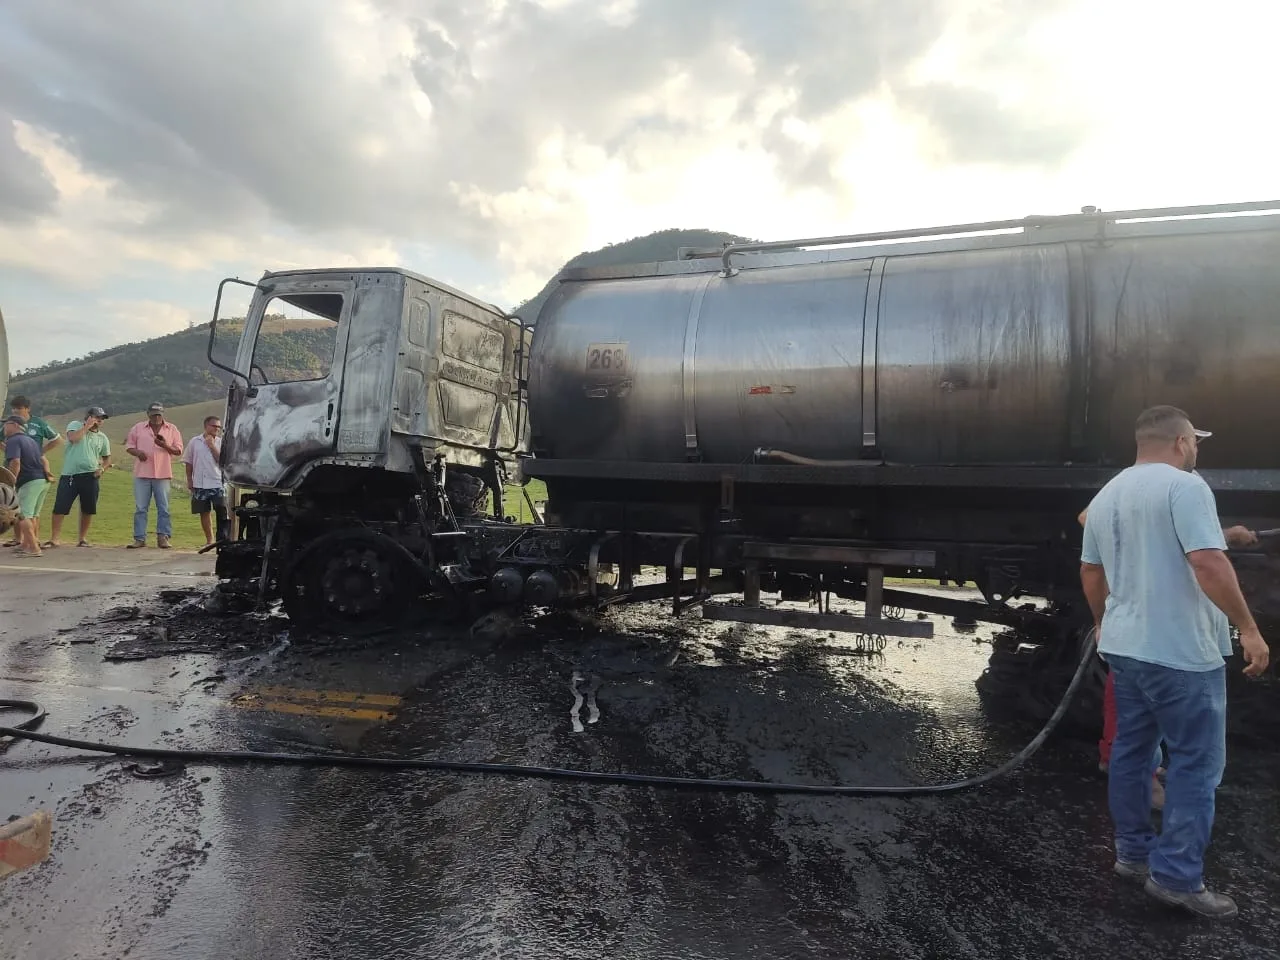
[{"xmin": 0, "ymin": 0, "xmax": 1280, "ymax": 369}]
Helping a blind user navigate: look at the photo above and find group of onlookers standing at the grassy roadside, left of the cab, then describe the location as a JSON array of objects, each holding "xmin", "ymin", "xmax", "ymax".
[{"xmin": 3, "ymin": 397, "xmax": 230, "ymax": 557}]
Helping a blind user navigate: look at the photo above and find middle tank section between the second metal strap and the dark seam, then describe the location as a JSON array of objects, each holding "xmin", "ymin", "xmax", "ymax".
[{"xmin": 877, "ymin": 244, "xmax": 1070, "ymax": 463}]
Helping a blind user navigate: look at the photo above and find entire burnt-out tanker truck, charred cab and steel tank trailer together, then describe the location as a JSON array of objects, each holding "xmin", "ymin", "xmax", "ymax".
[{"xmin": 207, "ymin": 204, "xmax": 1280, "ymax": 721}]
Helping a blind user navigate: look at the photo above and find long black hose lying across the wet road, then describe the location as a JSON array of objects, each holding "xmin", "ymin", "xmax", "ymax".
[{"xmin": 0, "ymin": 641, "xmax": 1093, "ymax": 796}]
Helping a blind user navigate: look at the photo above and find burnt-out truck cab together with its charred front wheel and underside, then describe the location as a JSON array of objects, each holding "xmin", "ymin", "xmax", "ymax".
[{"xmin": 209, "ymin": 269, "xmax": 527, "ymax": 630}]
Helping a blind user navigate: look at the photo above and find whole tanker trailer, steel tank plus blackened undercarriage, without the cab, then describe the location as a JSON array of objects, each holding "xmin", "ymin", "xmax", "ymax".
[{"xmin": 526, "ymin": 202, "xmax": 1280, "ymax": 727}]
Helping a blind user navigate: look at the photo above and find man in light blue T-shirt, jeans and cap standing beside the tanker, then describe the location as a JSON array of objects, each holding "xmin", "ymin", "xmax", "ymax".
[{"xmin": 1080, "ymin": 407, "xmax": 1270, "ymax": 916}]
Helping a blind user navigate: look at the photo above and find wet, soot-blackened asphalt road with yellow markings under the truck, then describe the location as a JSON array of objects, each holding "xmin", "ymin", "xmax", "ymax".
[{"xmin": 0, "ymin": 550, "xmax": 1280, "ymax": 960}]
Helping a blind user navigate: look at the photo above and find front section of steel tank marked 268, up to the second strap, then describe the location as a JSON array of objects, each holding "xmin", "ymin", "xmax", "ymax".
[{"xmin": 530, "ymin": 261, "xmax": 870, "ymax": 463}]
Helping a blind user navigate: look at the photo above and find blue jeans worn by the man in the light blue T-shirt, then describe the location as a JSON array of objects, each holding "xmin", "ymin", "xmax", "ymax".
[{"xmin": 1107, "ymin": 655, "xmax": 1226, "ymax": 892}]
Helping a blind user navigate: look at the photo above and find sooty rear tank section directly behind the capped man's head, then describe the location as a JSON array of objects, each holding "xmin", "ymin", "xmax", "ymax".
[{"xmin": 1084, "ymin": 230, "xmax": 1280, "ymax": 470}]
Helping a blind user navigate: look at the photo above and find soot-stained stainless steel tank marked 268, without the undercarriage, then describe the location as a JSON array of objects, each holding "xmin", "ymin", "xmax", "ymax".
[{"xmin": 530, "ymin": 204, "xmax": 1280, "ymax": 468}]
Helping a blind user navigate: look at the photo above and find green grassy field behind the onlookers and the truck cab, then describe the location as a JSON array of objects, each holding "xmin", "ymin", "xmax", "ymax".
[{"xmin": 17, "ymin": 401, "xmax": 547, "ymax": 549}]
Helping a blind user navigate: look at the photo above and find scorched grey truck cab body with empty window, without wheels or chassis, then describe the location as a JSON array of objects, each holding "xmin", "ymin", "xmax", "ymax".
[{"xmin": 209, "ymin": 269, "xmax": 529, "ymax": 493}]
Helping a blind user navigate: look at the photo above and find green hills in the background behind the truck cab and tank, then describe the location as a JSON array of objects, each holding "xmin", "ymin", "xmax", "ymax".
[{"xmin": 9, "ymin": 229, "xmax": 742, "ymax": 419}]
